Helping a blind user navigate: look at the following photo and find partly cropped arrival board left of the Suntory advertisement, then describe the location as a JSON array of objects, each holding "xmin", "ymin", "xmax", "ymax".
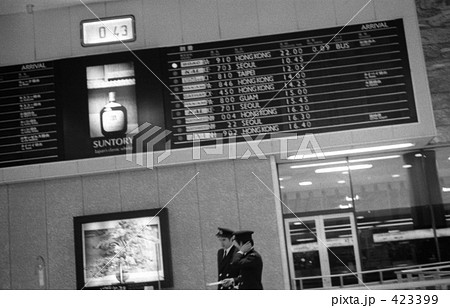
[{"xmin": 0, "ymin": 62, "xmax": 59, "ymax": 168}]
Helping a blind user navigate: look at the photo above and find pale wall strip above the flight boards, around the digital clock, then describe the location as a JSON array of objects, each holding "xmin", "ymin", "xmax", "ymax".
[{"xmin": 0, "ymin": 0, "xmax": 413, "ymax": 66}]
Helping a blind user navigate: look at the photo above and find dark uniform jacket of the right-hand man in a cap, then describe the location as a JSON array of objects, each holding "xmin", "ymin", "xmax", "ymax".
[{"xmin": 233, "ymin": 248, "xmax": 263, "ymax": 290}]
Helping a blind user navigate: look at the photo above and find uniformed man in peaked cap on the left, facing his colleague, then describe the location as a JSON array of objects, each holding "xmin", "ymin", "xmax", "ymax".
[{"xmin": 216, "ymin": 228, "xmax": 239, "ymax": 290}]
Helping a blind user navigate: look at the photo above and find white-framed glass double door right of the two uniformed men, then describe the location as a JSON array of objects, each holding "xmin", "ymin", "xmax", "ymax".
[{"xmin": 285, "ymin": 213, "xmax": 361, "ymax": 289}]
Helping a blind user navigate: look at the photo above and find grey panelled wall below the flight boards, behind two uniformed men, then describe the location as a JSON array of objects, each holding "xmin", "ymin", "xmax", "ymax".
[{"xmin": 0, "ymin": 160, "xmax": 284, "ymax": 289}]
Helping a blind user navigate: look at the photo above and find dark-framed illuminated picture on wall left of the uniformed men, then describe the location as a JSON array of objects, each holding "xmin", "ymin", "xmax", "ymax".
[{"xmin": 74, "ymin": 209, "xmax": 172, "ymax": 289}]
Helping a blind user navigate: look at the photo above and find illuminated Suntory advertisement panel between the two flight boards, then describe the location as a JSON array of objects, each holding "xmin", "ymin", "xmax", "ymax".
[{"xmin": 58, "ymin": 49, "xmax": 165, "ymax": 159}]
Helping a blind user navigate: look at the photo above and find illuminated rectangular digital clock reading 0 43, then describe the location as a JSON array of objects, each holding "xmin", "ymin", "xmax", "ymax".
[{"xmin": 80, "ymin": 15, "xmax": 136, "ymax": 47}]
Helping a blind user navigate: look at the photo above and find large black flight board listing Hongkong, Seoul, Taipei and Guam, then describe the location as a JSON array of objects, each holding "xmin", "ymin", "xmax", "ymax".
[{"xmin": 165, "ymin": 19, "xmax": 417, "ymax": 147}]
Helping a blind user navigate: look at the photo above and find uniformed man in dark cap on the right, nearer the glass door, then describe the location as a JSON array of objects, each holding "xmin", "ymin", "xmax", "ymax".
[{"xmin": 224, "ymin": 231, "xmax": 263, "ymax": 290}]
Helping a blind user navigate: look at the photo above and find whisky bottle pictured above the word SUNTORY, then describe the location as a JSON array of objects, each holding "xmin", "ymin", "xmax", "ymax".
[{"xmin": 100, "ymin": 92, "xmax": 128, "ymax": 137}]
